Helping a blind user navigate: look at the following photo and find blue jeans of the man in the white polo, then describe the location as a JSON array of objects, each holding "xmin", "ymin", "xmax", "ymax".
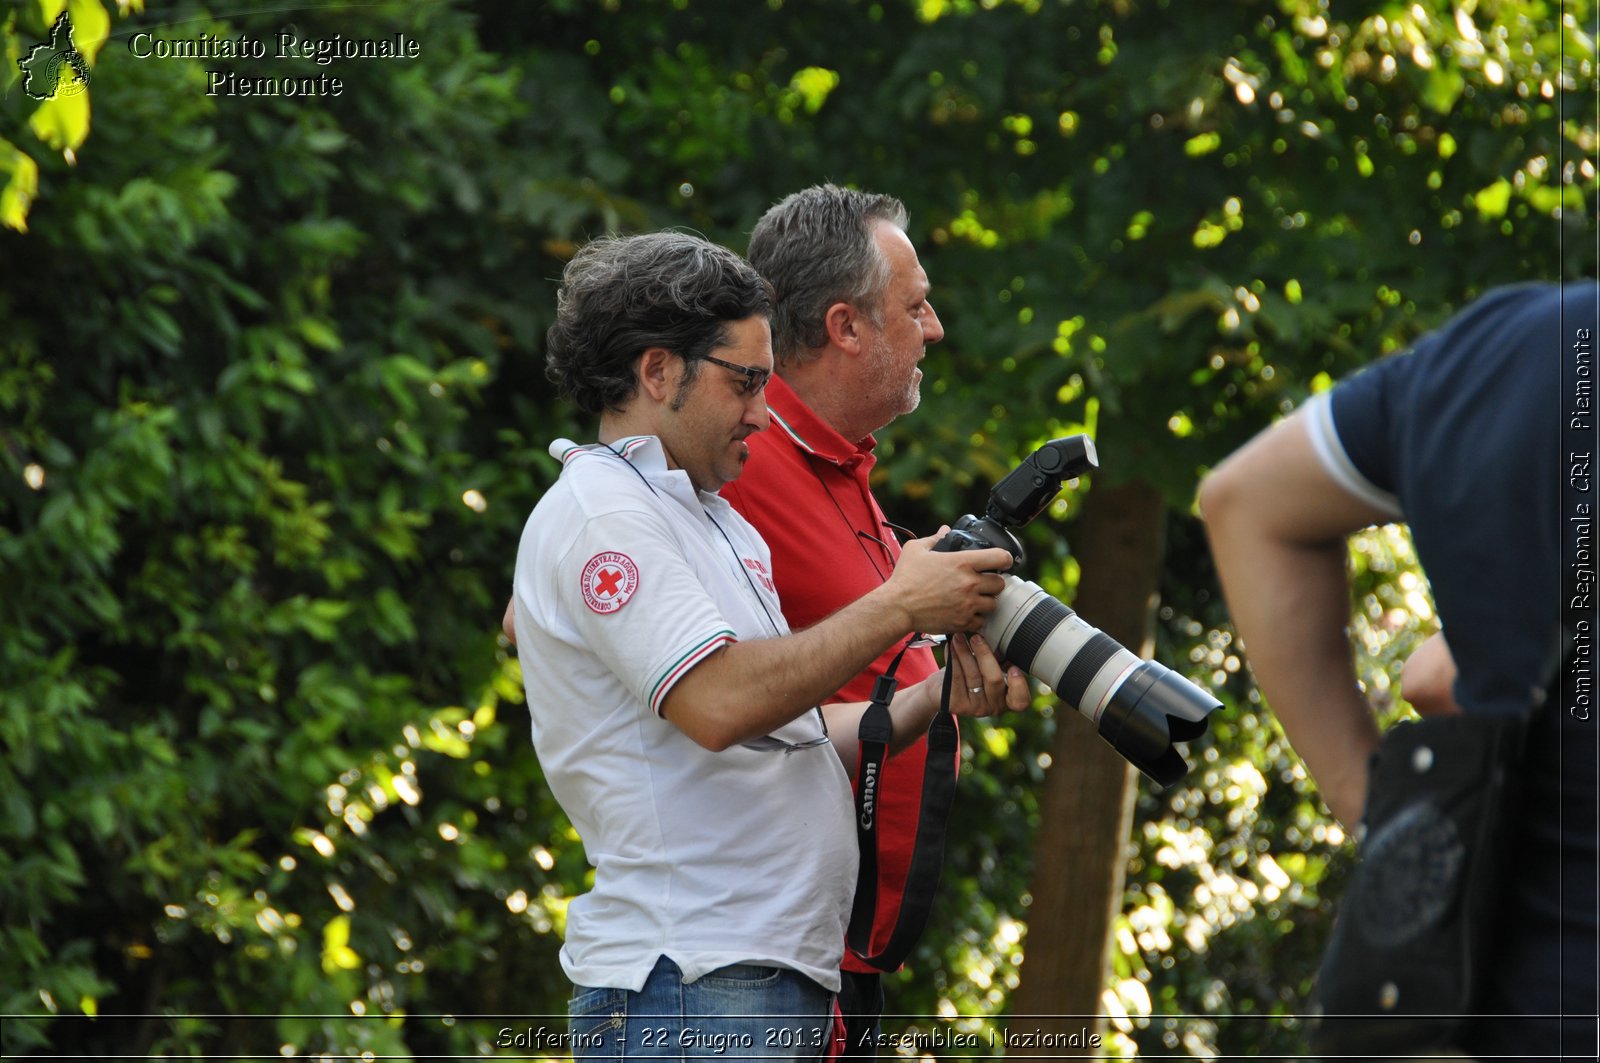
[{"xmin": 568, "ymin": 956, "xmax": 834, "ymax": 1060}]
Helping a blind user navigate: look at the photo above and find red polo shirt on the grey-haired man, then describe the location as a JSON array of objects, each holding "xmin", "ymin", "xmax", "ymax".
[{"xmin": 722, "ymin": 376, "xmax": 938, "ymax": 973}]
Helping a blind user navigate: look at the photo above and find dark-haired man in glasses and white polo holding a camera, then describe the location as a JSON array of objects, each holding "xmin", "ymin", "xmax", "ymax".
[{"xmin": 512, "ymin": 232, "xmax": 1010, "ymax": 1058}]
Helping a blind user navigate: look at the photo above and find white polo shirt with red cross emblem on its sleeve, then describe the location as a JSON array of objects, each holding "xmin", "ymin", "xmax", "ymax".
[{"xmin": 514, "ymin": 435, "xmax": 856, "ymax": 993}]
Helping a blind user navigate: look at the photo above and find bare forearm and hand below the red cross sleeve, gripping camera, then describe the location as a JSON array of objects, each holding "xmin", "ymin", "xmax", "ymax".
[{"xmin": 661, "ymin": 536, "xmax": 1011, "ymax": 751}]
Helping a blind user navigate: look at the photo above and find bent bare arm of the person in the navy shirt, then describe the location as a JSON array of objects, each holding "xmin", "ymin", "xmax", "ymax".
[{"xmin": 1200, "ymin": 415, "xmax": 1389, "ymax": 826}]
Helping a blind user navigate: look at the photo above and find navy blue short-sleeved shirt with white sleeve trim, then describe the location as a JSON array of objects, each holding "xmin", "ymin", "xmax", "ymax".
[{"xmin": 1314, "ymin": 285, "xmax": 1561, "ymax": 712}]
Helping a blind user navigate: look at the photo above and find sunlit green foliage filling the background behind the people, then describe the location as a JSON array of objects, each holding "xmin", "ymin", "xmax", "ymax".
[{"xmin": 0, "ymin": 0, "xmax": 1597, "ymax": 1057}]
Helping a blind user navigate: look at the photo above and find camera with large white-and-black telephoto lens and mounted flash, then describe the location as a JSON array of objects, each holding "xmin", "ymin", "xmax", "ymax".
[{"xmin": 933, "ymin": 435, "xmax": 1222, "ymax": 786}]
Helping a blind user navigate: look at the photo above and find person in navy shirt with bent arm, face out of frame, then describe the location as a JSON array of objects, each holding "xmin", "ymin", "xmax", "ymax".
[{"xmin": 1200, "ymin": 280, "xmax": 1600, "ymax": 1058}]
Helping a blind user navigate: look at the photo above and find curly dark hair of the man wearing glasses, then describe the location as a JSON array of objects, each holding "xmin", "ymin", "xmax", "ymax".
[{"xmin": 544, "ymin": 232, "xmax": 773, "ymax": 413}]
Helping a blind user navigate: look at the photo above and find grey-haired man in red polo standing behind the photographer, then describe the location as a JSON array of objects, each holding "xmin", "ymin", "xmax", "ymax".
[{"xmin": 723, "ymin": 184, "xmax": 1032, "ymax": 1058}]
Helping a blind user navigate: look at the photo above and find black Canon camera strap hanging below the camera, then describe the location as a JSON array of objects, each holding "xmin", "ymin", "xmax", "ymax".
[{"xmin": 845, "ymin": 642, "xmax": 960, "ymax": 972}]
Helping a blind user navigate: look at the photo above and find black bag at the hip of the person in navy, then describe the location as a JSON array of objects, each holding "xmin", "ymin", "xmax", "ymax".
[{"xmin": 1310, "ymin": 714, "xmax": 1530, "ymax": 1055}]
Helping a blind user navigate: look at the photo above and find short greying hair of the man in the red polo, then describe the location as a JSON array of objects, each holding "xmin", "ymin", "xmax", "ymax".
[{"xmin": 749, "ymin": 184, "xmax": 907, "ymax": 365}]
